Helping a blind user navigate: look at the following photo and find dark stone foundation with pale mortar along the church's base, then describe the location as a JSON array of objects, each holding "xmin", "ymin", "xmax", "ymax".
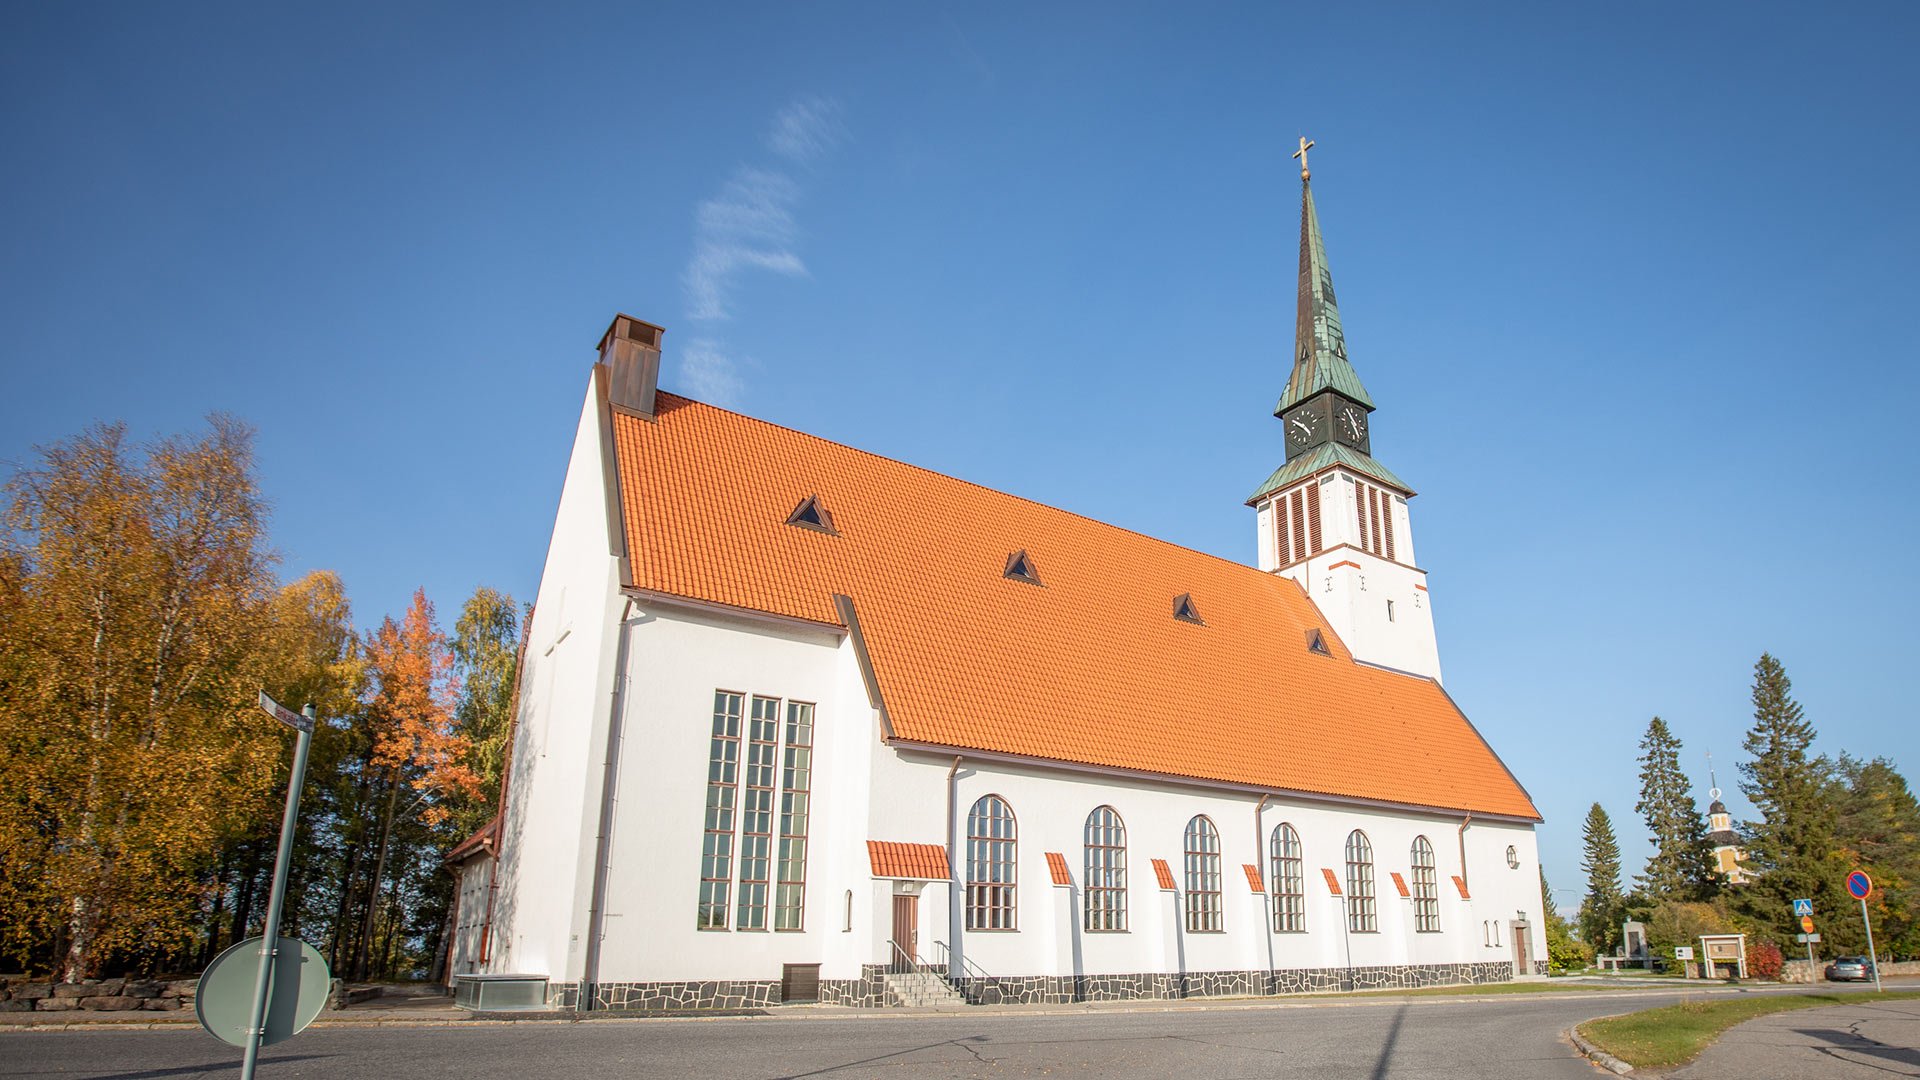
[{"xmin": 551, "ymin": 961, "xmax": 1513, "ymax": 1013}]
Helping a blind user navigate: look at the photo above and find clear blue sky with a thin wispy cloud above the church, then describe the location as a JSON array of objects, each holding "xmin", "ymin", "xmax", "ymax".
[{"xmin": 0, "ymin": 4, "xmax": 1920, "ymax": 903}]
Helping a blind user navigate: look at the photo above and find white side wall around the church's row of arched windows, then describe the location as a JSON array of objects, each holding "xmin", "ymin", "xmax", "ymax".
[{"xmin": 872, "ymin": 748, "xmax": 1540, "ymax": 978}]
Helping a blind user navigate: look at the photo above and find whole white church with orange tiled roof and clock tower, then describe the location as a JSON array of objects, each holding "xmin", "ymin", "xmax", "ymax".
[{"xmin": 449, "ymin": 161, "xmax": 1546, "ymax": 1009}]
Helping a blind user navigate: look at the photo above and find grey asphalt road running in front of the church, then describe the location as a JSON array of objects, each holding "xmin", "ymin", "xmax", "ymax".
[{"xmin": 0, "ymin": 994, "xmax": 1697, "ymax": 1080}]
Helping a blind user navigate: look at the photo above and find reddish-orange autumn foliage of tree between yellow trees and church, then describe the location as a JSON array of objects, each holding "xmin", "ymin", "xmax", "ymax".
[{"xmin": 365, "ymin": 590, "xmax": 484, "ymax": 824}]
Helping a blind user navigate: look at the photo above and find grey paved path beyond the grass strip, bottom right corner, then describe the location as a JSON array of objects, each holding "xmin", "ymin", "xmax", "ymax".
[{"xmin": 1667, "ymin": 999, "xmax": 1920, "ymax": 1080}]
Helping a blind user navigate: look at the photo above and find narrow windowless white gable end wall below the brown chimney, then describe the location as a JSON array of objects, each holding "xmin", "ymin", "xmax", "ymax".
[{"xmin": 486, "ymin": 374, "xmax": 620, "ymax": 980}]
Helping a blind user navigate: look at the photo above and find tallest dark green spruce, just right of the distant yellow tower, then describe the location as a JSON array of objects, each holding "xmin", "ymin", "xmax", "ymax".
[{"xmin": 1734, "ymin": 653, "xmax": 1845, "ymax": 940}]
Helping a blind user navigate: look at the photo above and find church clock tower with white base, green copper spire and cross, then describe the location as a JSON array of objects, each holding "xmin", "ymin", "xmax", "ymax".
[{"xmin": 1246, "ymin": 138, "xmax": 1440, "ymax": 680}]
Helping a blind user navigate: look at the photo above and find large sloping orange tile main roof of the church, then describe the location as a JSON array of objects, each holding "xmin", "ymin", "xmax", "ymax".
[{"xmin": 612, "ymin": 394, "xmax": 1540, "ymax": 821}]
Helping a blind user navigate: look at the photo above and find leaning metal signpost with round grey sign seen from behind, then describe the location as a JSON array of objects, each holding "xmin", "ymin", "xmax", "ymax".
[{"xmin": 194, "ymin": 690, "xmax": 328, "ymax": 1080}]
